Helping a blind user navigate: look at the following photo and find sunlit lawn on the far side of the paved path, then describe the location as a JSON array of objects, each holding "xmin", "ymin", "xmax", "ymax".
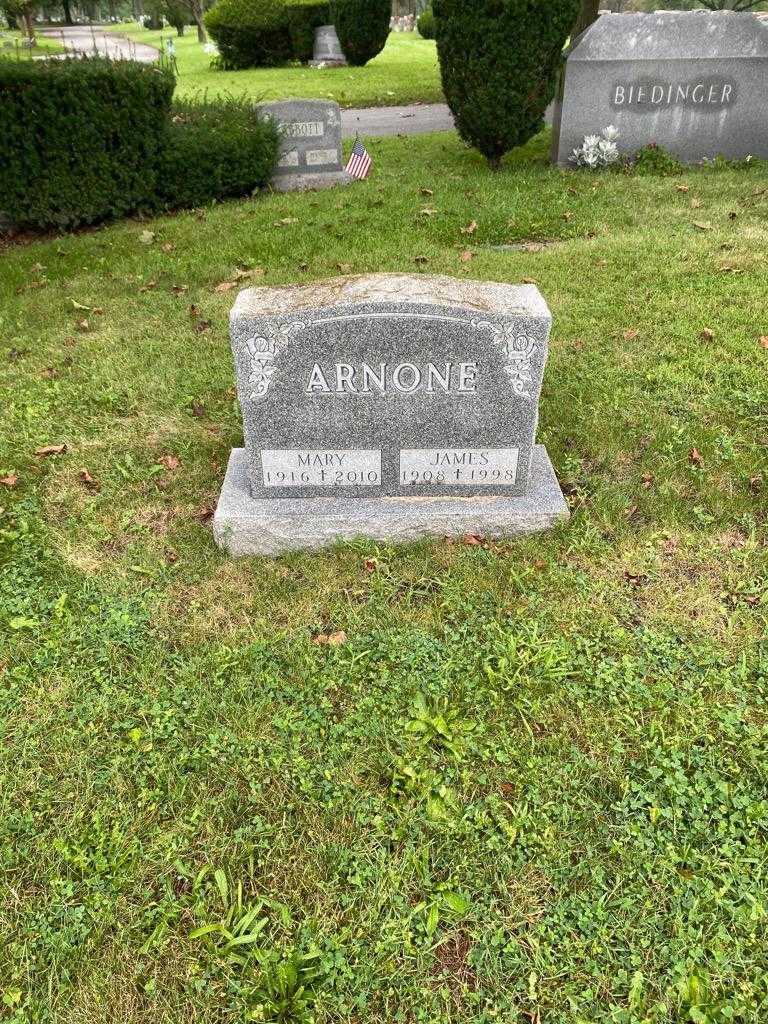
[{"xmin": 104, "ymin": 25, "xmax": 443, "ymax": 106}]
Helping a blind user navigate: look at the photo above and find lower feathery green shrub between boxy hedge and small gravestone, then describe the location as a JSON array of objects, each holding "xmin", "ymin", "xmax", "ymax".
[{"xmin": 158, "ymin": 98, "xmax": 280, "ymax": 209}]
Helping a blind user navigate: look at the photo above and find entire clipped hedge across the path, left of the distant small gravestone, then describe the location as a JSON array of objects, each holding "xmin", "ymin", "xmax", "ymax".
[{"xmin": 205, "ymin": 0, "xmax": 330, "ymax": 71}]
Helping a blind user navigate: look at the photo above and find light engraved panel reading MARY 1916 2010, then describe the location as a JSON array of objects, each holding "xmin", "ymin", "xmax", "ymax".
[{"xmin": 261, "ymin": 449, "xmax": 381, "ymax": 487}]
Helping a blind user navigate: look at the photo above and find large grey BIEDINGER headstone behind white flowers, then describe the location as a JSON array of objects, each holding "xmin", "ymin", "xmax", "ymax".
[{"xmin": 552, "ymin": 10, "xmax": 768, "ymax": 167}]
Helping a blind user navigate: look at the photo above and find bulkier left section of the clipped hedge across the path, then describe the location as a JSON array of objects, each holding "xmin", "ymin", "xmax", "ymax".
[{"xmin": 205, "ymin": 0, "xmax": 293, "ymax": 71}]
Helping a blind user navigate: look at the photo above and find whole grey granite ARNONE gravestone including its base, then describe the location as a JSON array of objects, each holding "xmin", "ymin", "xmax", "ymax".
[{"xmin": 214, "ymin": 274, "xmax": 568, "ymax": 555}]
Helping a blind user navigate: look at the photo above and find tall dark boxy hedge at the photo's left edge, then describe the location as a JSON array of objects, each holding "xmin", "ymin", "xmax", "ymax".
[{"xmin": 0, "ymin": 57, "xmax": 174, "ymax": 227}]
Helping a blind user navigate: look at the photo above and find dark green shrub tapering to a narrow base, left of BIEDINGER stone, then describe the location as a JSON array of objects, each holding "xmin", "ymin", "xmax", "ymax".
[{"xmin": 432, "ymin": 0, "xmax": 581, "ymax": 169}]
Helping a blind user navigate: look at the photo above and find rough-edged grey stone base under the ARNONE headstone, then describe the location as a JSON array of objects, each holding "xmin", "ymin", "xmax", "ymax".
[{"xmin": 213, "ymin": 444, "xmax": 570, "ymax": 555}]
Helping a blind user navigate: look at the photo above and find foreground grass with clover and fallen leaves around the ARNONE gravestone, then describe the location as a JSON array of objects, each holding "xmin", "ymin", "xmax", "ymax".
[{"xmin": 0, "ymin": 132, "xmax": 768, "ymax": 1024}]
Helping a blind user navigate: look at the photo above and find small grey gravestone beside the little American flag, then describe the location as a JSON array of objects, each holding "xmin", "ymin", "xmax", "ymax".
[{"xmin": 257, "ymin": 99, "xmax": 353, "ymax": 191}]
